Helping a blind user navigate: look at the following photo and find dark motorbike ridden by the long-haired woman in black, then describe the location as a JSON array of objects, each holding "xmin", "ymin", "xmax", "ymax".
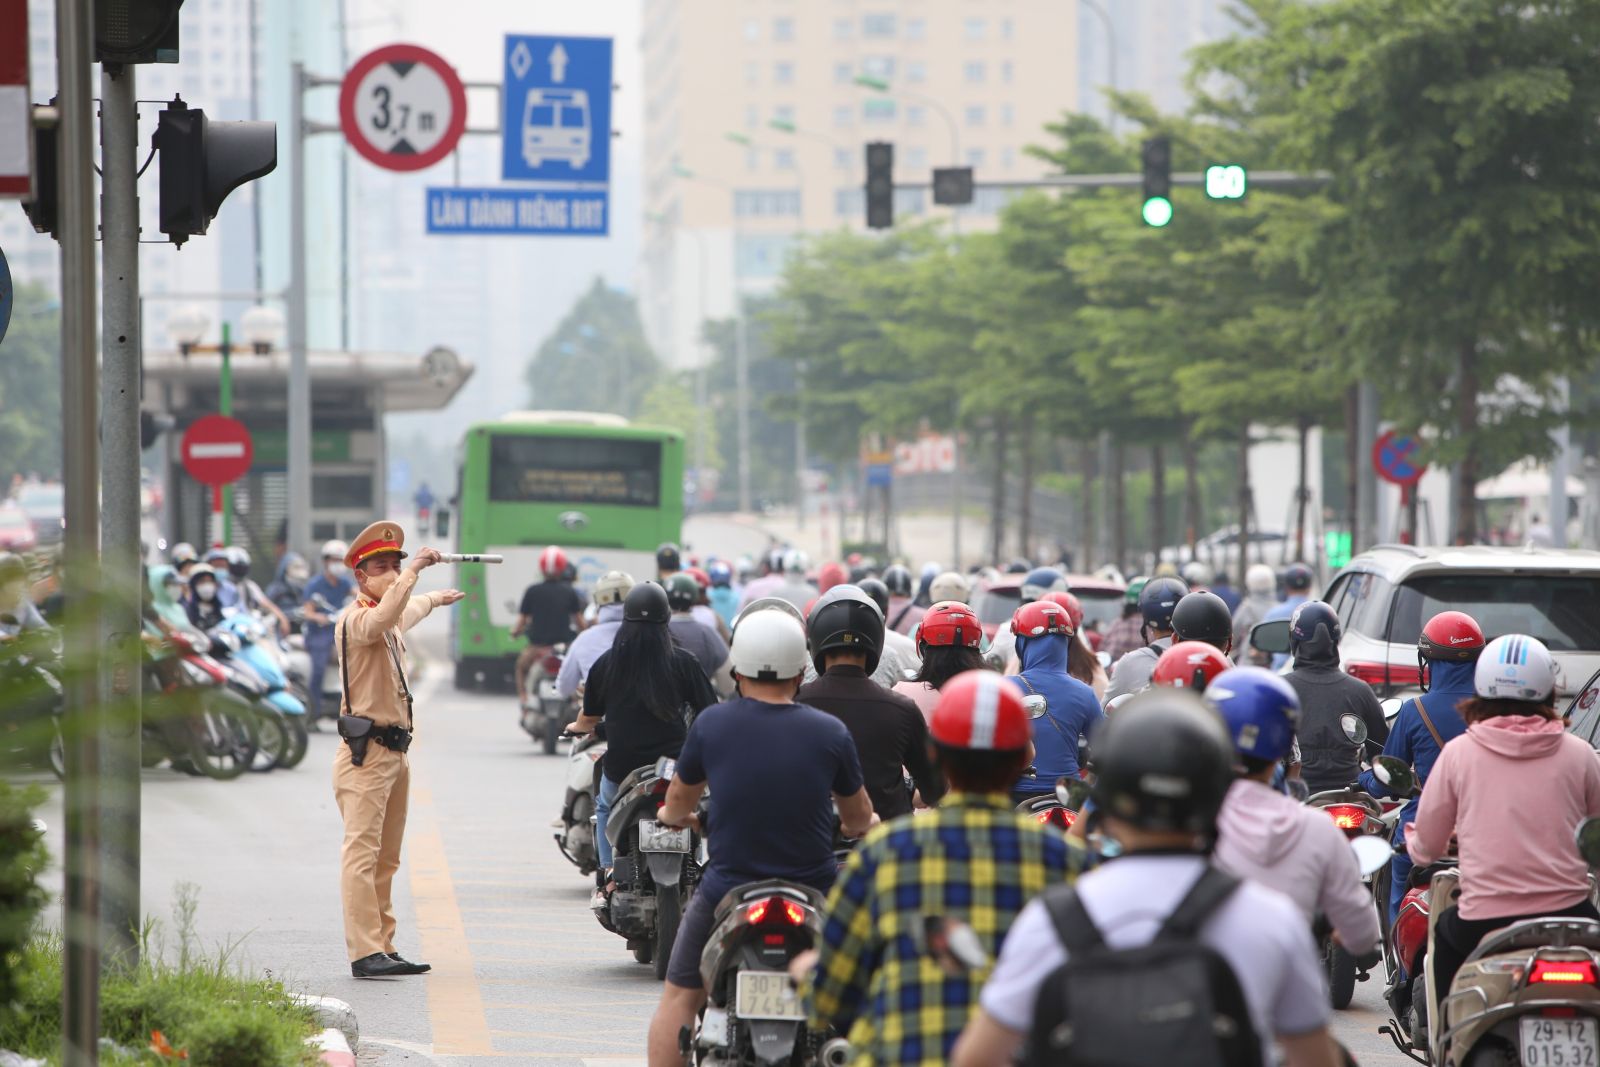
[{"xmin": 595, "ymin": 758, "xmax": 706, "ymax": 979}]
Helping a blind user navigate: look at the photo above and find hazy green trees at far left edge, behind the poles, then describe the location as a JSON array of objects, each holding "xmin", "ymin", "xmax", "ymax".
[{"xmin": 0, "ymin": 285, "xmax": 61, "ymax": 478}]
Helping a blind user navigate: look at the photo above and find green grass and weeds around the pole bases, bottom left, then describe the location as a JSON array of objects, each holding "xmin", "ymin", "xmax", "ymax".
[{"xmin": 0, "ymin": 885, "xmax": 318, "ymax": 1067}]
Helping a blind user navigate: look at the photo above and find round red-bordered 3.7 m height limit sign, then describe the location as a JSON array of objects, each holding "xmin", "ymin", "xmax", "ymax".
[{"xmin": 339, "ymin": 45, "xmax": 467, "ymax": 171}]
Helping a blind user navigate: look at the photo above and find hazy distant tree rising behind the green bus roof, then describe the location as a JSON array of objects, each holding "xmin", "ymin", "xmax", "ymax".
[{"xmin": 525, "ymin": 278, "xmax": 661, "ymax": 418}]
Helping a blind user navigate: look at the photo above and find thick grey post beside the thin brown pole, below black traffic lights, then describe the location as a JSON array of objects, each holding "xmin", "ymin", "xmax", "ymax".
[{"xmin": 99, "ymin": 58, "xmax": 142, "ymax": 965}]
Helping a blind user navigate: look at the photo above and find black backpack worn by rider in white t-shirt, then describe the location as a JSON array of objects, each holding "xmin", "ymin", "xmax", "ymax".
[{"xmin": 1022, "ymin": 867, "xmax": 1261, "ymax": 1067}]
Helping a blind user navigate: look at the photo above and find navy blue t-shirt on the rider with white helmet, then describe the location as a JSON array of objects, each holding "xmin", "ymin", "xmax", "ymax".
[{"xmin": 677, "ymin": 697, "xmax": 861, "ymax": 901}]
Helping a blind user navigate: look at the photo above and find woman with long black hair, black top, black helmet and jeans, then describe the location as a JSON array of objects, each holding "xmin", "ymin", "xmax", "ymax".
[{"xmin": 568, "ymin": 582, "xmax": 717, "ymax": 889}]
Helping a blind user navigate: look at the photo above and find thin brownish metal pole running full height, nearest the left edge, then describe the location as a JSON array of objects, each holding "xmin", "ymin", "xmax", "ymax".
[{"xmin": 56, "ymin": 0, "xmax": 101, "ymax": 1067}]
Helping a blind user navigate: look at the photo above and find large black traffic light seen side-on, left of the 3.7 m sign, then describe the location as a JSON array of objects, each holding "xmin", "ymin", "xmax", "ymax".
[{"xmin": 155, "ymin": 96, "xmax": 278, "ymax": 246}]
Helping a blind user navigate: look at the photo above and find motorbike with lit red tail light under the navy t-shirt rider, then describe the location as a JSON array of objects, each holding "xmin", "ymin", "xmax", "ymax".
[{"xmin": 678, "ymin": 878, "xmax": 850, "ymax": 1067}]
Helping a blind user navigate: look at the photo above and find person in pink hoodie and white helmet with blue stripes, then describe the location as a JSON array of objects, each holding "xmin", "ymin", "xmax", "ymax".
[{"xmin": 1406, "ymin": 633, "xmax": 1600, "ymax": 1000}]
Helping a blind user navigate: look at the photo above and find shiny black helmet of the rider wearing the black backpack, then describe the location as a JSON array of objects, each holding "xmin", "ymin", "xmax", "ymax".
[{"xmin": 1091, "ymin": 688, "xmax": 1234, "ymax": 837}]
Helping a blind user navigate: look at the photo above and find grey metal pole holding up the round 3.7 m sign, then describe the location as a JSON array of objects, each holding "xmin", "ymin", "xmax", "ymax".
[{"xmin": 286, "ymin": 62, "xmax": 310, "ymax": 555}]
